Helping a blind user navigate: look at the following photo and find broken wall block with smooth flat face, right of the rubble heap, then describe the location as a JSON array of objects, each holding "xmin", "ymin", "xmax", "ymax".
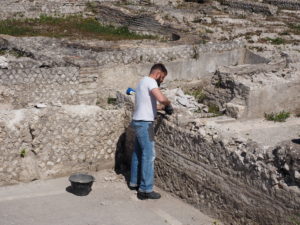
[{"xmin": 204, "ymin": 59, "xmax": 300, "ymax": 119}]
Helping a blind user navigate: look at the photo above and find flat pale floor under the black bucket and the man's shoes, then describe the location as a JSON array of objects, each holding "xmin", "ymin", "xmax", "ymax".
[{"xmin": 0, "ymin": 170, "xmax": 221, "ymax": 225}]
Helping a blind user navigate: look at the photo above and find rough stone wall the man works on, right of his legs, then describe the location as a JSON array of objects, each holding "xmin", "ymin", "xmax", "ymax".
[{"xmin": 156, "ymin": 119, "xmax": 300, "ymax": 225}]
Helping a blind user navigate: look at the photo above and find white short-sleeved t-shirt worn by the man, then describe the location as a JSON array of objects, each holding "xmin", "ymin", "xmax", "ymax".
[{"xmin": 133, "ymin": 77, "xmax": 158, "ymax": 121}]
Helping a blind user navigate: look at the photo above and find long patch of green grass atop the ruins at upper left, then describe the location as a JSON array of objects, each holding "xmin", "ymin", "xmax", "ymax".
[{"xmin": 0, "ymin": 15, "xmax": 154, "ymax": 40}]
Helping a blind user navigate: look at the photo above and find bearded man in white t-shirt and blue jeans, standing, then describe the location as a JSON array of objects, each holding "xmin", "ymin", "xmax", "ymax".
[{"xmin": 129, "ymin": 63, "xmax": 173, "ymax": 200}]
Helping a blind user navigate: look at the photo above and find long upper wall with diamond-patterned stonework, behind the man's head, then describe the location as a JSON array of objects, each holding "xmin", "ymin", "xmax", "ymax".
[{"xmin": 0, "ymin": 37, "xmax": 251, "ymax": 109}]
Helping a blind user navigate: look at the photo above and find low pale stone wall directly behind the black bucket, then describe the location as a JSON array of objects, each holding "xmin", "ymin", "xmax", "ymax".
[{"xmin": 0, "ymin": 105, "xmax": 124, "ymax": 185}]
